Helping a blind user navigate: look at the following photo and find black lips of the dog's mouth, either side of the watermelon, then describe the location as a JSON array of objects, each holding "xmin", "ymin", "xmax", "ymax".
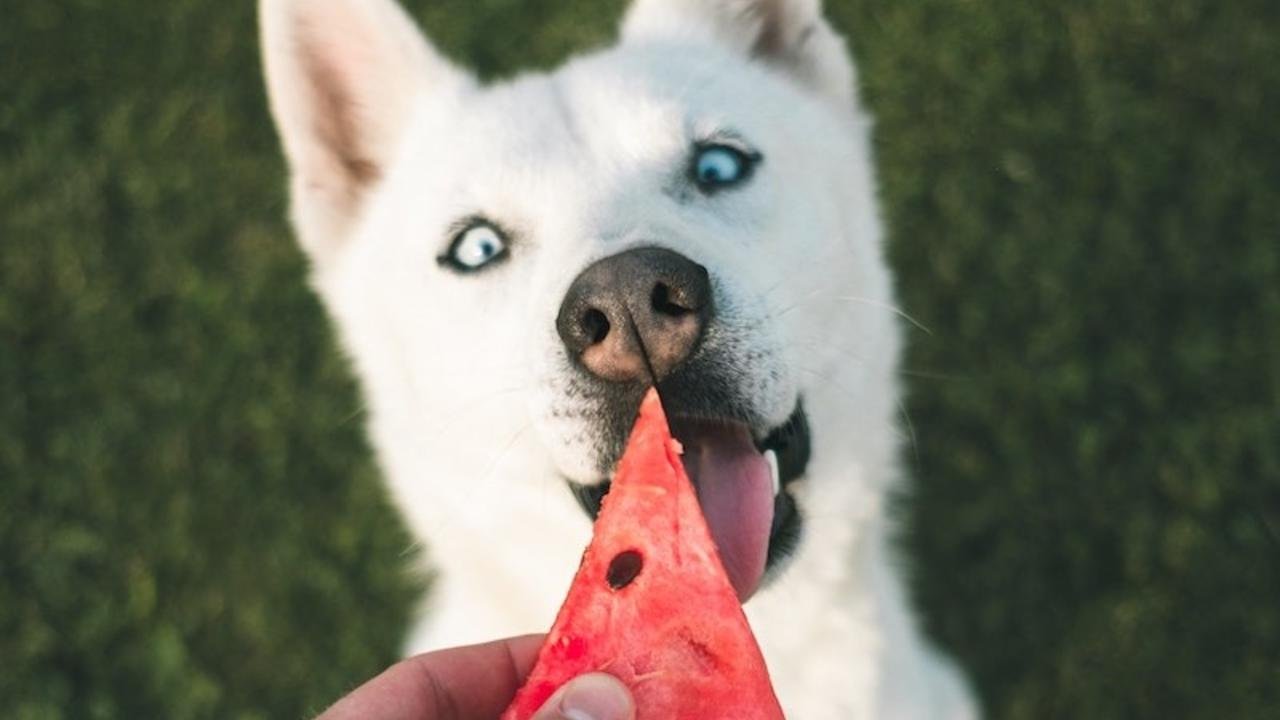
[{"xmin": 566, "ymin": 401, "xmax": 813, "ymax": 585}]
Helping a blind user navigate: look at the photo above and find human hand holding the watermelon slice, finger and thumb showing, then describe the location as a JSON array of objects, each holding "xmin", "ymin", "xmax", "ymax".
[{"xmin": 316, "ymin": 635, "xmax": 635, "ymax": 720}]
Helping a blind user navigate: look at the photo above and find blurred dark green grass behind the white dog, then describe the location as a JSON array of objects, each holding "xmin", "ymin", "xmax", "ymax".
[{"xmin": 0, "ymin": 0, "xmax": 1280, "ymax": 720}]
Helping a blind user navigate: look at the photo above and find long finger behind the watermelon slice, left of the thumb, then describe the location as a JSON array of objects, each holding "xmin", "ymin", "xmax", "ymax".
[{"xmin": 316, "ymin": 635, "xmax": 543, "ymax": 720}]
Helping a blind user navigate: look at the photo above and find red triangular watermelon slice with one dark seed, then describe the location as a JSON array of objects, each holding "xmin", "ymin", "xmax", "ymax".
[{"xmin": 502, "ymin": 389, "xmax": 782, "ymax": 720}]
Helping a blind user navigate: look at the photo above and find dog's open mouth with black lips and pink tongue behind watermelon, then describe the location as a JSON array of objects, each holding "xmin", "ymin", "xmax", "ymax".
[{"xmin": 570, "ymin": 402, "xmax": 810, "ymax": 602}]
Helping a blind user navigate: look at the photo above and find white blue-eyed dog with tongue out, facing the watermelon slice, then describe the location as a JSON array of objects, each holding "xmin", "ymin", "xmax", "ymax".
[{"xmin": 261, "ymin": 0, "xmax": 975, "ymax": 720}]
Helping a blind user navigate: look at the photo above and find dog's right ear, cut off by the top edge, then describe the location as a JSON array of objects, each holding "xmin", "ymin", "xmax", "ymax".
[{"xmin": 622, "ymin": 0, "xmax": 854, "ymax": 102}]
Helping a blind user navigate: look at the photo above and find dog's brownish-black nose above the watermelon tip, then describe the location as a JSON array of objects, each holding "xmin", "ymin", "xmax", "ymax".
[{"xmin": 556, "ymin": 247, "xmax": 712, "ymax": 382}]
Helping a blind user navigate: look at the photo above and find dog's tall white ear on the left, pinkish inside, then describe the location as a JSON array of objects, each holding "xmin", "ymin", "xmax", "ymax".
[{"xmin": 259, "ymin": 0, "xmax": 467, "ymax": 263}]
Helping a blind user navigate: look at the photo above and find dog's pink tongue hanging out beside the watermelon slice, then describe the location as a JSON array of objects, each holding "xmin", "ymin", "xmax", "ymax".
[{"xmin": 675, "ymin": 423, "xmax": 773, "ymax": 602}]
